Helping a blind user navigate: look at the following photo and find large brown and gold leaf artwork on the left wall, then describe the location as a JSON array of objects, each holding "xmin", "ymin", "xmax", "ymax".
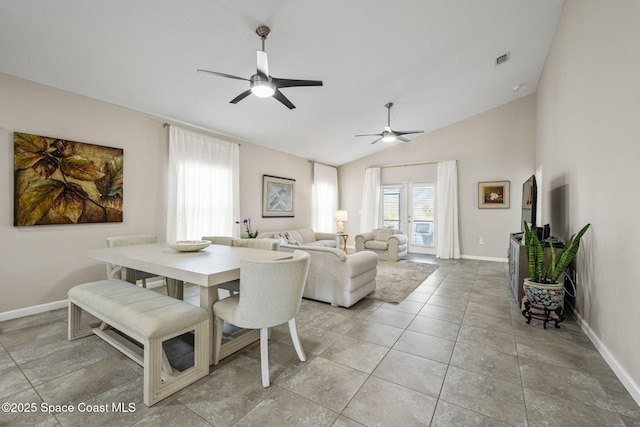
[{"xmin": 13, "ymin": 132, "xmax": 123, "ymax": 226}]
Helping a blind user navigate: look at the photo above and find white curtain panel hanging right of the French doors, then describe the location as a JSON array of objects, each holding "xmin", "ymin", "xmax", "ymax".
[{"xmin": 436, "ymin": 160, "xmax": 460, "ymax": 259}]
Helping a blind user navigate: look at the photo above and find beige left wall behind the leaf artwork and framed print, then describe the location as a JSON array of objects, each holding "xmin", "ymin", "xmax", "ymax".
[{"xmin": 0, "ymin": 74, "xmax": 312, "ymax": 315}]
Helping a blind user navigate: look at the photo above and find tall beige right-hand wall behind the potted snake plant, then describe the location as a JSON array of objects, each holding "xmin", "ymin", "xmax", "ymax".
[{"xmin": 536, "ymin": 0, "xmax": 640, "ymax": 394}]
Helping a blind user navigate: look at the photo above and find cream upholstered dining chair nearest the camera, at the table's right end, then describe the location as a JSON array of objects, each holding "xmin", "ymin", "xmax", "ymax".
[{"xmin": 213, "ymin": 250, "xmax": 310, "ymax": 387}]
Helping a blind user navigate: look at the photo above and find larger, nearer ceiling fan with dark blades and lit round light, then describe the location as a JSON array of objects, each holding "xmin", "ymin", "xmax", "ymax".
[{"xmin": 198, "ymin": 25, "xmax": 322, "ymax": 110}]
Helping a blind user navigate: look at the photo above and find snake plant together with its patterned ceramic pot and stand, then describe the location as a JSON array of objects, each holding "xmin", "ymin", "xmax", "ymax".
[{"xmin": 521, "ymin": 222, "xmax": 591, "ymax": 329}]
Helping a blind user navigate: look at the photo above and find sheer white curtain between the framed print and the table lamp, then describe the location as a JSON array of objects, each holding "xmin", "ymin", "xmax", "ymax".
[{"xmin": 311, "ymin": 163, "xmax": 338, "ymax": 232}]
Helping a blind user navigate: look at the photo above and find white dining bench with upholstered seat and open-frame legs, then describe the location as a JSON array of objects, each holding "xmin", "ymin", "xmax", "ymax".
[{"xmin": 68, "ymin": 279, "xmax": 210, "ymax": 406}]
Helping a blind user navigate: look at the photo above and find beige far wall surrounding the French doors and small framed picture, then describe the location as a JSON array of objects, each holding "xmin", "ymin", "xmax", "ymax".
[{"xmin": 339, "ymin": 95, "xmax": 535, "ymax": 259}]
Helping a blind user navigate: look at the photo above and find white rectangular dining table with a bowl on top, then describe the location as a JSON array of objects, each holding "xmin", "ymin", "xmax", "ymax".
[{"xmin": 88, "ymin": 243, "xmax": 291, "ymax": 365}]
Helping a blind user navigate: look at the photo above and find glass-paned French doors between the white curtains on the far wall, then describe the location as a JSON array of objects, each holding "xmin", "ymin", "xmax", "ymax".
[{"xmin": 381, "ymin": 183, "xmax": 436, "ymax": 254}]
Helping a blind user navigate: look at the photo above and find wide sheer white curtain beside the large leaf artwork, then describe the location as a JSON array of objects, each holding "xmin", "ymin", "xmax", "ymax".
[{"xmin": 167, "ymin": 126, "xmax": 240, "ymax": 241}]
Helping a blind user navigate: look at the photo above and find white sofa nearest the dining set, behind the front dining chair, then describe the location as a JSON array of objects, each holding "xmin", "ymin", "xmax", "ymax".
[{"xmin": 280, "ymin": 243, "xmax": 378, "ymax": 307}]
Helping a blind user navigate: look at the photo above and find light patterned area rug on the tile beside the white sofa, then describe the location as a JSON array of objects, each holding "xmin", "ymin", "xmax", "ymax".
[{"xmin": 368, "ymin": 260, "xmax": 438, "ymax": 304}]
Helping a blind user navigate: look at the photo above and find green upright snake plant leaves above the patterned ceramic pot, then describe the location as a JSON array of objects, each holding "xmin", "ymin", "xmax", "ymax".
[{"xmin": 524, "ymin": 222, "xmax": 591, "ymax": 283}]
